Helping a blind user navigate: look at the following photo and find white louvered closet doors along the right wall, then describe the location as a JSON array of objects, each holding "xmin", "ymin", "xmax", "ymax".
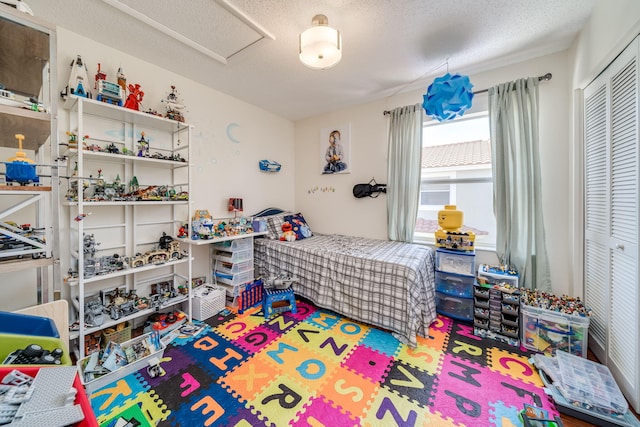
[{"xmin": 584, "ymin": 38, "xmax": 640, "ymax": 411}]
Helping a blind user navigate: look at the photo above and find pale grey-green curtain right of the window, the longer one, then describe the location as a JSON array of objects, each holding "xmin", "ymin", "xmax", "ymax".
[{"xmin": 489, "ymin": 78, "xmax": 551, "ymax": 291}]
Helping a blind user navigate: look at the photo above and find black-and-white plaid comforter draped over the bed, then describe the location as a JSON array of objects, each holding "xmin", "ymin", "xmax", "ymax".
[{"xmin": 254, "ymin": 234, "xmax": 436, "ymax": 347}]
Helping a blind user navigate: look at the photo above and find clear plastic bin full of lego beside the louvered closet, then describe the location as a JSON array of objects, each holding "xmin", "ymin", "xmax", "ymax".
[{"xmin": 520, "ymin": 304, "xmax": 589, "ymax": 357}]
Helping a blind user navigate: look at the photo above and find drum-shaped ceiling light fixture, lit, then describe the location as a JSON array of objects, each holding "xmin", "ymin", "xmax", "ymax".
[{"xmin": 299, "ymin": 15, "xmax": 342, "ymax": 70}]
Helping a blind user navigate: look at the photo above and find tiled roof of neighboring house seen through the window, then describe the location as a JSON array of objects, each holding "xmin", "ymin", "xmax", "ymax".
[{"xmin": 422, "ymin": 140, "xmax": 491, "ymax": 168}]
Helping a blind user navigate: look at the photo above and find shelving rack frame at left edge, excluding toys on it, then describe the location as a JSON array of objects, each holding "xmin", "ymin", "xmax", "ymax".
[{"xmin": 0, "ymin": 4, "xmax": 61, "ymax": 304}]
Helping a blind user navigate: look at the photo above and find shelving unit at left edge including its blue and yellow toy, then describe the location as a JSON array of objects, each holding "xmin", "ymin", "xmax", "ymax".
[{"xmin": 0, "ymin": 3, "xmax": 61, "ymax": 304}]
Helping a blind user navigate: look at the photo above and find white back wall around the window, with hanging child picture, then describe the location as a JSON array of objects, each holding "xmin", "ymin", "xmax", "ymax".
[{"xmin": 295, "ymin": 51, "xmax": 572, "ymax": 293}]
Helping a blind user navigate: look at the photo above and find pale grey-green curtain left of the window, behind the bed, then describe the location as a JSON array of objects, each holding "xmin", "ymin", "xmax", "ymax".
[{"xmin": 387, "ymin": 104, "xmax": 422, "ymax": 242}]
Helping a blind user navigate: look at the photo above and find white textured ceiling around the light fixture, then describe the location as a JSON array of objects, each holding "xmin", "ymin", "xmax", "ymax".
[{"xmin": 26, "ymin": 0, "xmax": 596, "ymax": 120}]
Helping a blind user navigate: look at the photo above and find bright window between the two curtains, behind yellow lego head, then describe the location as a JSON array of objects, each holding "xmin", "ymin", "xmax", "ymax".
[{"xmin": 415, "ymin": 112, "xmax": 496, "ymax": 248}]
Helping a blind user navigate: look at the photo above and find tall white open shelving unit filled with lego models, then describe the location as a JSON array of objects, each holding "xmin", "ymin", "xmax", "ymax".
[{"xmin": 61, "ymin": 94, "xmax": 192, "ymax": 359}]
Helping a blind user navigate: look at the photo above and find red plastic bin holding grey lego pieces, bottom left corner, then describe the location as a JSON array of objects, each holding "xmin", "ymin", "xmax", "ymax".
[{"xmin": 0, "ymin": 366, "xmax": 98, "ymax": 427}]
